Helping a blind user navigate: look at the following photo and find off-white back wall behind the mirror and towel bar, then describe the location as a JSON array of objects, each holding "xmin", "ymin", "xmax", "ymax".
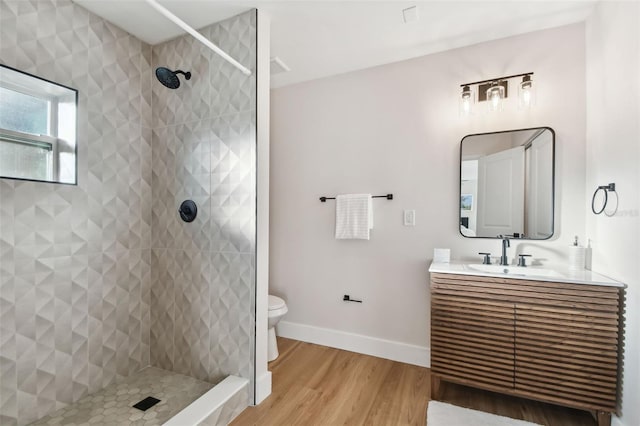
[{"xmin": 270, "ymin": 24, "xmax": 585, "ymax": 360}]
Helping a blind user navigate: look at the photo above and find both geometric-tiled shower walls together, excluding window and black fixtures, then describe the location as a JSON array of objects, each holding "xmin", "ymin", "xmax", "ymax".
[{"xmin": 0, "ymin": 0, "xmax": 256, "ymax": 425}]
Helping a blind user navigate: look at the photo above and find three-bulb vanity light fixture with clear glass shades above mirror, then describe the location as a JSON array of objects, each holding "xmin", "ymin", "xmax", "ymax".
[{"xmin": 460, "ymin": 72, "xmax": 535, "ymax": 116}]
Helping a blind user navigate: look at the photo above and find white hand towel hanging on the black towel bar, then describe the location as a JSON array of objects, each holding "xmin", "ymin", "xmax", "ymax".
[{"xmin": 336, "ymin": 194, "xmax": 373, "ymax": 240}]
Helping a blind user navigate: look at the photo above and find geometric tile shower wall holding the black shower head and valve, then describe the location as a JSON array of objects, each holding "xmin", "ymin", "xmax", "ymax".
[{"xmin": 150, "ymin": 11, "xmax": 257, "ymax": 399}]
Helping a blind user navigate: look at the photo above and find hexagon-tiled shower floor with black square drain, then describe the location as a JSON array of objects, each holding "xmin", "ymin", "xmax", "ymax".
[{"xmin": 31, "ymin": 367, "xmax": 214, "ymax": 426}]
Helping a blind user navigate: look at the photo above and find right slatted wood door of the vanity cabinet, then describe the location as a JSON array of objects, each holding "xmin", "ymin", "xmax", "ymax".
[{"xmin": 515, "ymin": 302, "xmax": 619, "ymax": 411}]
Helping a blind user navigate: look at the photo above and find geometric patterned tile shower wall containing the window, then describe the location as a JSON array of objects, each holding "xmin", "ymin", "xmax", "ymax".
[{"xmin": 0, "ymin": 0, "xmax": 153, "ymax": 425}]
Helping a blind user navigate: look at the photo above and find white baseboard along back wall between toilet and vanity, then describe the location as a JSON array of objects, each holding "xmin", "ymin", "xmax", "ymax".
[{"xmin": 276, "ymin": 321, "xmax": 431, "ymax": 367}]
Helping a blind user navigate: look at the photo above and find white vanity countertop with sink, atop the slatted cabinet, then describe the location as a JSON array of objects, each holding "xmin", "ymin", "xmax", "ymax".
[{"xmin": 429, "ymin": 261, "xmax": 627, "ymax": 288}]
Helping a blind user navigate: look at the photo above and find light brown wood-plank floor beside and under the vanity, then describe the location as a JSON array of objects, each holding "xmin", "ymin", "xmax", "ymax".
[{"xmin": 231, "ymin": 337, "xmax": 596, "ymax": 426}]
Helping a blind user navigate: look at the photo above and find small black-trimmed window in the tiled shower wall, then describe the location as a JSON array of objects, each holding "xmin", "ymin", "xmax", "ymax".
[{"xmin": 0, "ymin": 65, "xmax": 78, "ymax": 185}]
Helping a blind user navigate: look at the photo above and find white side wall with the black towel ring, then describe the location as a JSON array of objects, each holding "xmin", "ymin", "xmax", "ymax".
[{"xmin": 583, "ymin": 2, "xmax": 640, "ymax": 426}]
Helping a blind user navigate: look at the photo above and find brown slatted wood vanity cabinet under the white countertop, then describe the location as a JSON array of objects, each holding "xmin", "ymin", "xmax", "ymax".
[{"xmin": 431, "ymin": 273, "xmax": 622, "ymax": 426}]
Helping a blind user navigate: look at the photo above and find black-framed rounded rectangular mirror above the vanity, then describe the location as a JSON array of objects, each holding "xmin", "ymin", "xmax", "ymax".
[{"xmin": 458, "ymin": 127, "xmax": 555, "ymax": 240}]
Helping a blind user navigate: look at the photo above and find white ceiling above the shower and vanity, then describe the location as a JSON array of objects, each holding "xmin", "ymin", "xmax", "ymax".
[{"xmin": 73, "ymin": 0, "xmax": 595, "ymax": 87}]
